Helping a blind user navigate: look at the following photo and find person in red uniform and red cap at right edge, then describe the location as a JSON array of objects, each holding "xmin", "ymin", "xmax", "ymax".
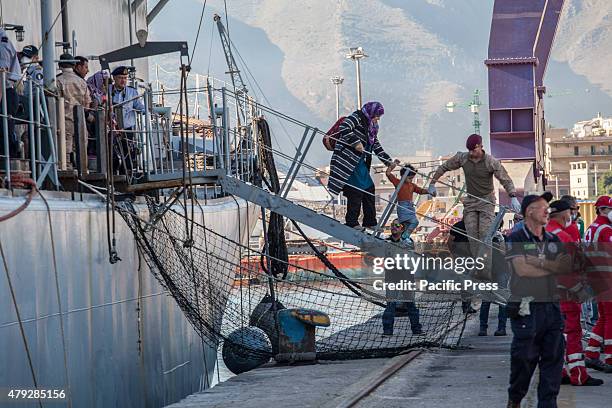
[{"xmin": 584, "ymin": 196, "xmax": 612, "ymax": 373}]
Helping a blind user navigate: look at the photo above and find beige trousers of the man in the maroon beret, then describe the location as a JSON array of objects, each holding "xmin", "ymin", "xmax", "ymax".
[{"xmin": 463, "ymin": 193, "xmax": 495, "ymax": 280}]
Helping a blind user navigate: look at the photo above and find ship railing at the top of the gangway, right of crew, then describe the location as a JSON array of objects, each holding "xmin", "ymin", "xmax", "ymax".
[{"xmin": 75, "ymin": 84, "xmax": 257, "ymax": 191}]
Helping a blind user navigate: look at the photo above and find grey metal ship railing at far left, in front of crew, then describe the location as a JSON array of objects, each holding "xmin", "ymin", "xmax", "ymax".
[{"xmin": 0, "ymin": 71, "xmax": 63, "ymax": 188}]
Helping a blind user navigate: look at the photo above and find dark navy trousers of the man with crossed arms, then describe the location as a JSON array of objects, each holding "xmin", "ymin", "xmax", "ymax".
[{"xmin": 508, "ymin": 302, "xmax": 565, "ymax": 408}]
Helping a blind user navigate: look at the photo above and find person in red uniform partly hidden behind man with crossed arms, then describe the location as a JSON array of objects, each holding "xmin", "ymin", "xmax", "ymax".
[{"xmin": 546, "ymin": 200, "xmax": 603, "ymax": 386}]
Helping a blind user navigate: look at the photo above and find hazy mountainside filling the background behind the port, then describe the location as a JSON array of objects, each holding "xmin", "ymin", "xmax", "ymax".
[{"xmin": 152, "ymin": 0, "xmax": 612, "ymax": 163}]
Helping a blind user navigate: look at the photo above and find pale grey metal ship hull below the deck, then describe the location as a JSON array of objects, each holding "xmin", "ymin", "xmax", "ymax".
[{"xmin": 0, "ymin": 191, "xmax": 256, "ymax": 407}]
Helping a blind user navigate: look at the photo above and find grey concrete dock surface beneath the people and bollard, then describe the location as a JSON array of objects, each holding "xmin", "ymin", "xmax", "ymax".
[{"xmin": 170, "ymin": 316, "xmax": 612, "ymax": 408}]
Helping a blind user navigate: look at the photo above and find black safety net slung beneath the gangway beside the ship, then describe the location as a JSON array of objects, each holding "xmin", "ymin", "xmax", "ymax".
[{"xmin": 119, "ymin": 202, "xmax": 465, "ymax": 359}]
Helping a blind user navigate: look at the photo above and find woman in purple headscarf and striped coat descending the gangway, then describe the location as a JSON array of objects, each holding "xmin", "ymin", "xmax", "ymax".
[{"xmin": 328, "ymin": 102, "xmax": 391, "ymax": 229}]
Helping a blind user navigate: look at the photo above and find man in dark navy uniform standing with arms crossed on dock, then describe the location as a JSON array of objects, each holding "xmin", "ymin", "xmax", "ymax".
[{"xmin": 506, "ymin": 195, "xmax": 572, "ymax": 408}]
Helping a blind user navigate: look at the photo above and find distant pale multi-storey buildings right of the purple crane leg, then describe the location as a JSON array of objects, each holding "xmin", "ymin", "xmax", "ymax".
[{"xmin": 545, "ymin": 114, "xmax": 612, "ymax": 198}]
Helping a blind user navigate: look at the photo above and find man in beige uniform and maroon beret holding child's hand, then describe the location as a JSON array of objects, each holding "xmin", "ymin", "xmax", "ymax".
[{"xmin": 428, "ymin": 134, "xmax": 521, "ymax": 278}]
